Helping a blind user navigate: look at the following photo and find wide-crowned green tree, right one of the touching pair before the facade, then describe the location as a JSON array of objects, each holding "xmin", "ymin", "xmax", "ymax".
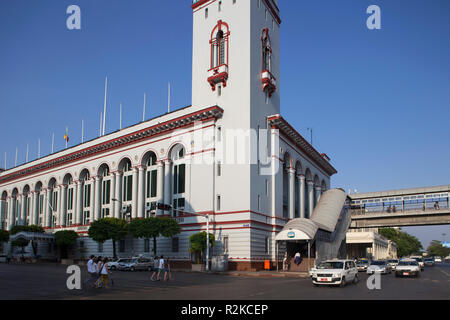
[{"xmin": 129, "ymin": 217, "xmax": 181, "ymax": 254}]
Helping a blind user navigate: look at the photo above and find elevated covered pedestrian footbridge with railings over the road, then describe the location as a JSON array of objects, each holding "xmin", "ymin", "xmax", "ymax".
[{"xmin": 348, "ymin": 185, "xmax": 450, "ymax": 229}]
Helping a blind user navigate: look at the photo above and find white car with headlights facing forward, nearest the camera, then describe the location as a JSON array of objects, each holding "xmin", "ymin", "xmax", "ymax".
[{"xmin": 309, "ymin": 260, "xmax": 358, "ymax": 287}]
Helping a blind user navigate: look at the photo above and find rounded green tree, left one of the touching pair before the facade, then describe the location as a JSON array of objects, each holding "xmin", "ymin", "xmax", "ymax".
[{"xmin": 88, "ymin": 218, "xmax": 128, "ymax": 259}]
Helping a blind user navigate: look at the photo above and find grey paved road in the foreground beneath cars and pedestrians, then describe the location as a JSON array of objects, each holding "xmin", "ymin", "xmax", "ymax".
[{"xmin": 0, "ymin": 263, "xmax": 450, "ymax": 300}]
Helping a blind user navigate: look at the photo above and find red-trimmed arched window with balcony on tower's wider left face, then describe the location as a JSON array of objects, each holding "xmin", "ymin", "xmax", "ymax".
[{"xmin": 208, "ymin": 20, "xmax": 230, "ymax": 91}]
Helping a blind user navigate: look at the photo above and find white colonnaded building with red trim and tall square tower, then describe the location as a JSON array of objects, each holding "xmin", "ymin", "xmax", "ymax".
[{"xmin": 0, "ymin": 0, "xmax": 337, "ymax": 269}]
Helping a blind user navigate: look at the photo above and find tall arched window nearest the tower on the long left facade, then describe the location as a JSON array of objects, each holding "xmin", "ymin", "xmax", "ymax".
[{"xmin": 171, "ymin": 145, "xmax": 186, "ymax": 216}]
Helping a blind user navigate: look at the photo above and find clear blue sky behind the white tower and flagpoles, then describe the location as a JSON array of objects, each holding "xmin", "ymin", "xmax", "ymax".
[{"xmin": 0, "ymin": 0, "xmax": 450, "ymax": 246}]
